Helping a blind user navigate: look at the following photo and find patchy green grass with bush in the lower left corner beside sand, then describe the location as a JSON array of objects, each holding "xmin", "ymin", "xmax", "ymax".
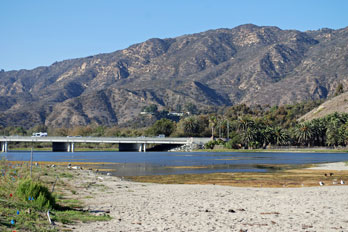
[{"xmin": 0, "ymin": 160, "xmax": 111, "ymax": 231}]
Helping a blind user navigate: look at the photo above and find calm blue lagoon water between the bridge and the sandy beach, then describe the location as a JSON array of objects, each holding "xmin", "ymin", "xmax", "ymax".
[{"xmin": 0, "ymin": 151, "xmax": 348, "ymax": 176}]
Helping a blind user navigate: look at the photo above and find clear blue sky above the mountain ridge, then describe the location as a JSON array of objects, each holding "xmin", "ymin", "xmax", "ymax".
[{"xmin": 0, "ymin": 0, "xmax": 348, "ymax": 71}]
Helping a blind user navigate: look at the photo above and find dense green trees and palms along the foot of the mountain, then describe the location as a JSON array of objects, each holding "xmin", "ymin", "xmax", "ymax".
[{"xmin": 0, "ymin": 101, "xmax": 348, "ymax": 149}]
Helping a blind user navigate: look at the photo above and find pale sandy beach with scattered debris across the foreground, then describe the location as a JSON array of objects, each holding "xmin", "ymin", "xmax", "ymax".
[{"xmin": 69, "ymin": 163, "xmax": 348, "ymax": 232}]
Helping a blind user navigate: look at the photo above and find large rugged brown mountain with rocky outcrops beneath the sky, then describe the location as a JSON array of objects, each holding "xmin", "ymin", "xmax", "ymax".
[{"xmin": 0, "ymin": 25, "xmax": 348, "ymax": 127}]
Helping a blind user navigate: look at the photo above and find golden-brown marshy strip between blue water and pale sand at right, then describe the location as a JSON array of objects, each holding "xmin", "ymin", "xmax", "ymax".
[{"xmin": 128, "ymin": 169, "xmax": 348, "ymax": 188}]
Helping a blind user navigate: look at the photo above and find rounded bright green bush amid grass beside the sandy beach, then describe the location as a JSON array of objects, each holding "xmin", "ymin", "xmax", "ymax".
[{"xmin": 17, "ymin": 179, "xmax": 56, "ymax": 210}]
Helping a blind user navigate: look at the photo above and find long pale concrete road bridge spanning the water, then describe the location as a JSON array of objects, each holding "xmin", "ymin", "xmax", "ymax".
[{"xmin": 0, "ymin": 136, "xmax": 210, "ymax": 152}]
